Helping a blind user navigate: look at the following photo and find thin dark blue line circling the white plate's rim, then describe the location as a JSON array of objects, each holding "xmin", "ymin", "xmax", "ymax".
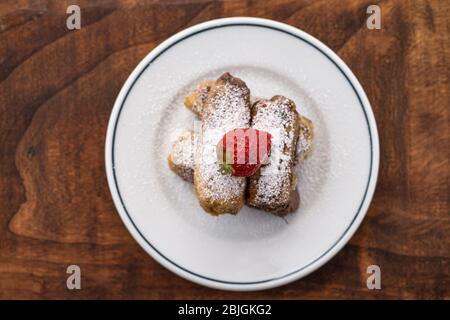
[{"xmin": 112, "ymin": 23, "xmax": 373, "ymax": 285}]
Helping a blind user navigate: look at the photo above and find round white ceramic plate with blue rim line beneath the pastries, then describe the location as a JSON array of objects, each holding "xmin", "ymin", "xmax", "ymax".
[{"xmin": 106, "ymin": 18, "xmax": 379, "ymax": 290}]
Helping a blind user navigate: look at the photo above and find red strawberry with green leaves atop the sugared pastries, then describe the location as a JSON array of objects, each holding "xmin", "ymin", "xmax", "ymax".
[{"xmin": 216, "ymin": 128, "xmax": 272, "ymax": 177}]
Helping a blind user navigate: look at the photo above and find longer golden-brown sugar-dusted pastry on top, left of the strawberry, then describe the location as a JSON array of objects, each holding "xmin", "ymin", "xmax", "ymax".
[{"xmin": 194, "ymin": 73, "xmax": 250, "ymax": 215}]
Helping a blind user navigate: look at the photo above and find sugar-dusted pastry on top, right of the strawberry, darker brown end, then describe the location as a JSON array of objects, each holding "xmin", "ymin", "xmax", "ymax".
[{"xmin": 247, "ymin": 96, "xmax": 300, "ymax": 215}]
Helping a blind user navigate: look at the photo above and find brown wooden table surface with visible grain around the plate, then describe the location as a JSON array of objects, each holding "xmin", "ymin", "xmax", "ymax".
[{"xmin": 0, "ymin": 0, "xmax": 450, "ymax": 299}]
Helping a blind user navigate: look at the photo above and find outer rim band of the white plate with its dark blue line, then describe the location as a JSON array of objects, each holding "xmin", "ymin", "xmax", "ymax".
[{"xmin": 105, "ymin": 17, "xmax": 379, "ymax": 291}]
